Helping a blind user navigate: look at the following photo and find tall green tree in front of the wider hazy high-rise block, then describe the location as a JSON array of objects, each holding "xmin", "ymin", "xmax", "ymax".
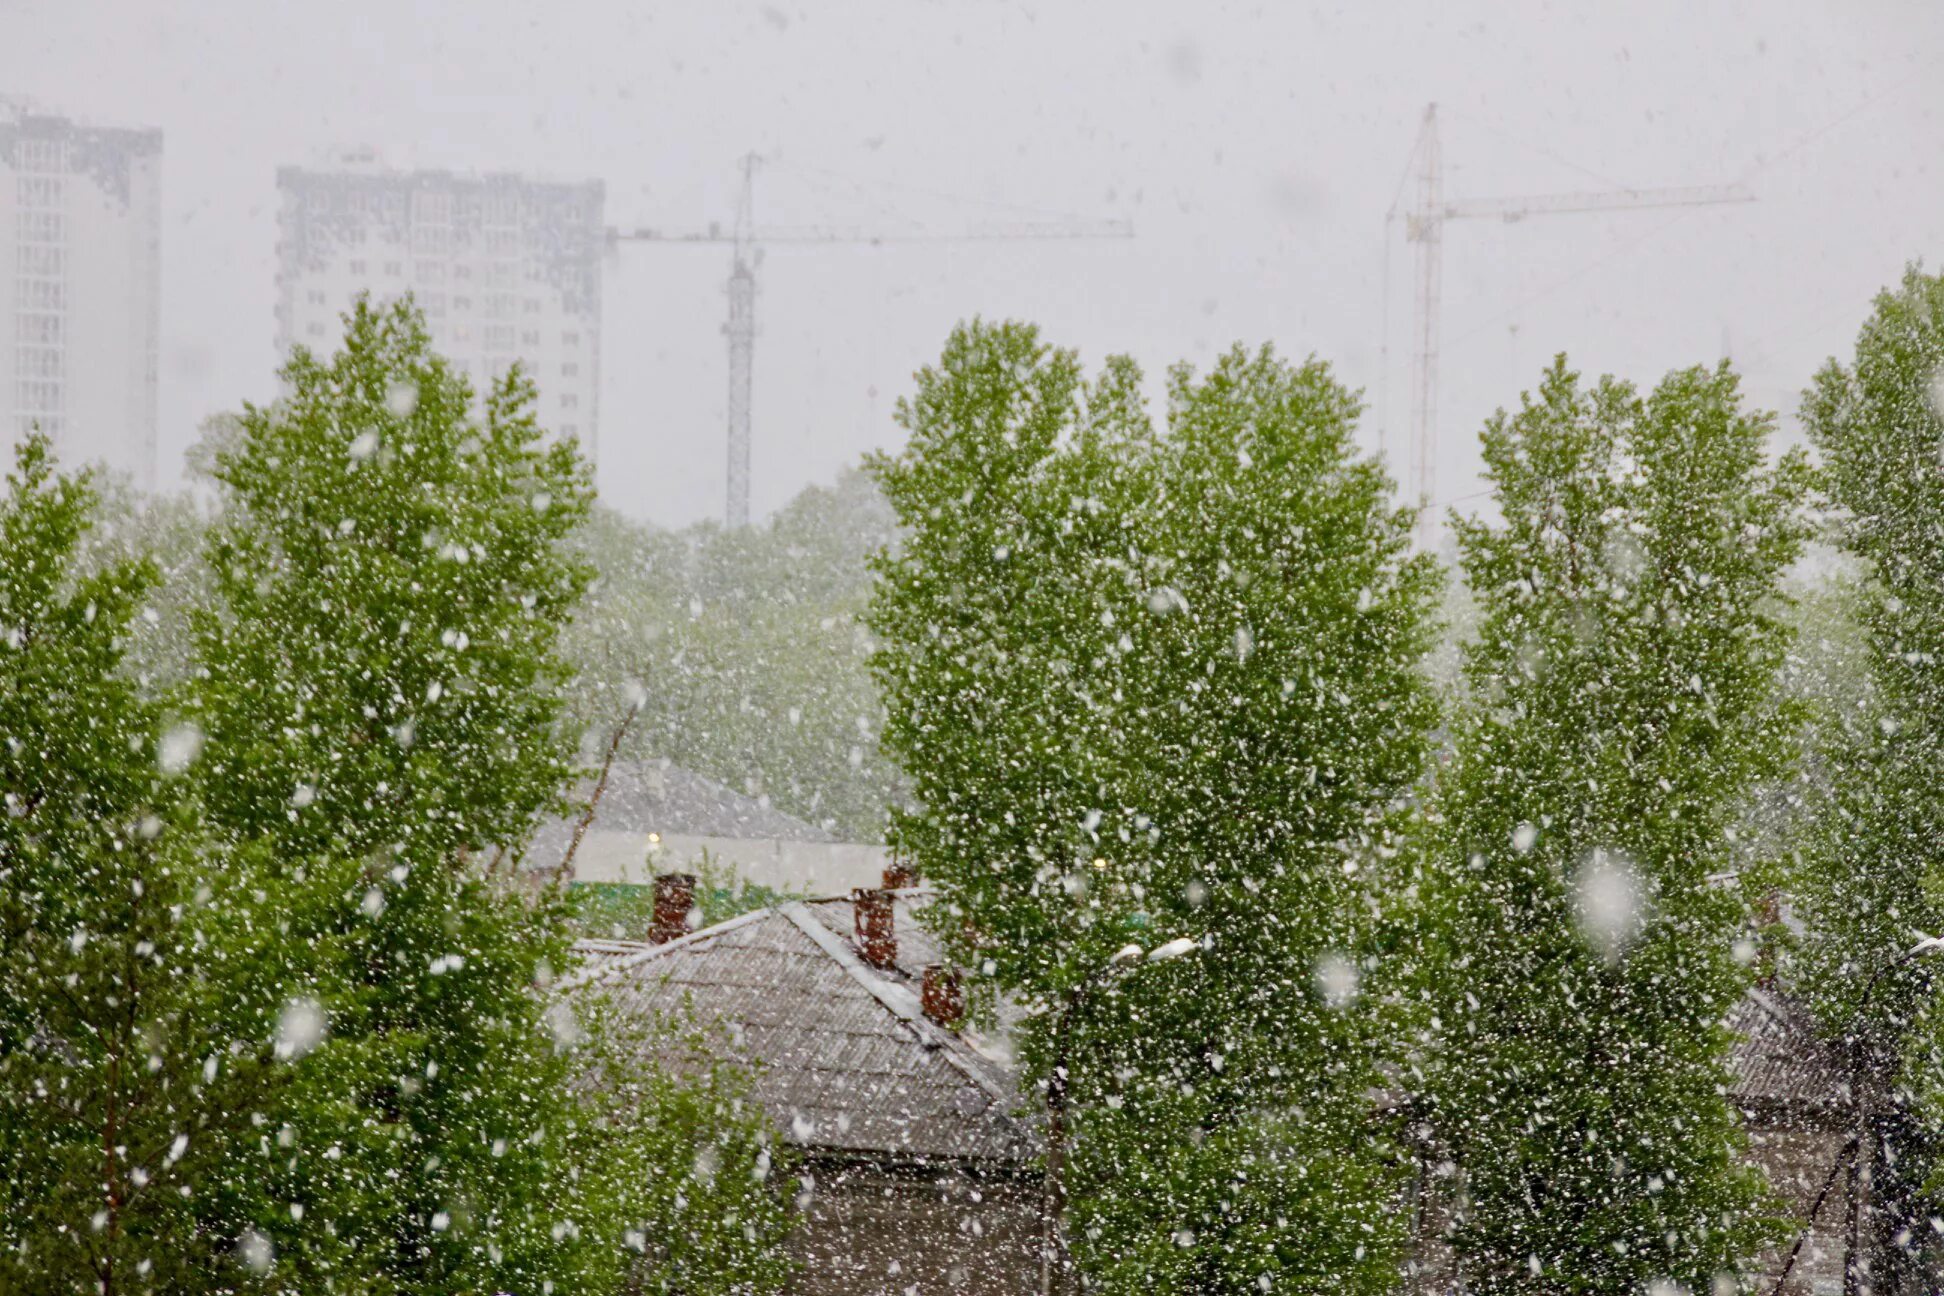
[{"xmin": 194, "ymin": 301, "xmax": 780, "ymax": 1294}]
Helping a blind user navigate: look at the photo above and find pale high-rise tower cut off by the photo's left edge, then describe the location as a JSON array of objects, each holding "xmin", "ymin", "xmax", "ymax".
[{"xmin": 0, "ymin": 103, "xmax": 161, "ymax": 488}]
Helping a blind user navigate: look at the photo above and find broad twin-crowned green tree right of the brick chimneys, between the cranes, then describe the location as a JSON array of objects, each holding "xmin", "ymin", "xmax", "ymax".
[{"xmin": 871, "ymin": 323, "xmax": 1437, "ymax": 1292}]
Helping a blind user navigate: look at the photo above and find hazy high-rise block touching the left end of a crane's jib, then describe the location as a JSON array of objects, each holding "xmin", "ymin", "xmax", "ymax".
[{"xmin": 276, "ymin": 155, "xmax": 607, "ymax": 457}]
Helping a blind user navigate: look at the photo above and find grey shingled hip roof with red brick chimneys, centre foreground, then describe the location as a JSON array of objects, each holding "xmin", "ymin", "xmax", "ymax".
[{"xmin": 583, "ymin": 896, "xmax": 1032, "ymax": 1168}]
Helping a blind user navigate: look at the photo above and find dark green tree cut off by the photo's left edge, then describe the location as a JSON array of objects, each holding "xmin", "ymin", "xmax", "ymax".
[{"xmin": 0, "ymin": 435, "xmax": 371, "ymax": 1292}]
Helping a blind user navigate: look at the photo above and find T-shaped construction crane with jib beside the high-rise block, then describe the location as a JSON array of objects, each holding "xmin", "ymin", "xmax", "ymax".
[{"xmin": 607, "ymin": 153, "xmax": 1133, "ymax": 527}]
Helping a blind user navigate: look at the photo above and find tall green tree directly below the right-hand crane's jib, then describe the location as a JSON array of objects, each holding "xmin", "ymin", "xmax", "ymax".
[{"xmin": 1421, "ymin": 358, "xmax": 1806, "ymax": 1292}]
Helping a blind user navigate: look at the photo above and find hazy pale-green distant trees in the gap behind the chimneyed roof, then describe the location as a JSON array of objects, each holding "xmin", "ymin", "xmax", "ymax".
[{"xmin": 564, "ymin": 472, "xmax": 898, "ymax": 841}]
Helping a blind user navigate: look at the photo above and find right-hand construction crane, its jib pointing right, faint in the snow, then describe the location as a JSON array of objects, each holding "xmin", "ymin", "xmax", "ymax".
[{"xmin": 1390, "ymin": 103, "xmax": 1755, "ymax": 546}]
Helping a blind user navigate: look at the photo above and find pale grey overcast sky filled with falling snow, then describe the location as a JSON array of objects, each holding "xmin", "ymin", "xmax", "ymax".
[{"xmin": 0, "ymin": 0, "xmax": 1944, "ymax": 525}]
